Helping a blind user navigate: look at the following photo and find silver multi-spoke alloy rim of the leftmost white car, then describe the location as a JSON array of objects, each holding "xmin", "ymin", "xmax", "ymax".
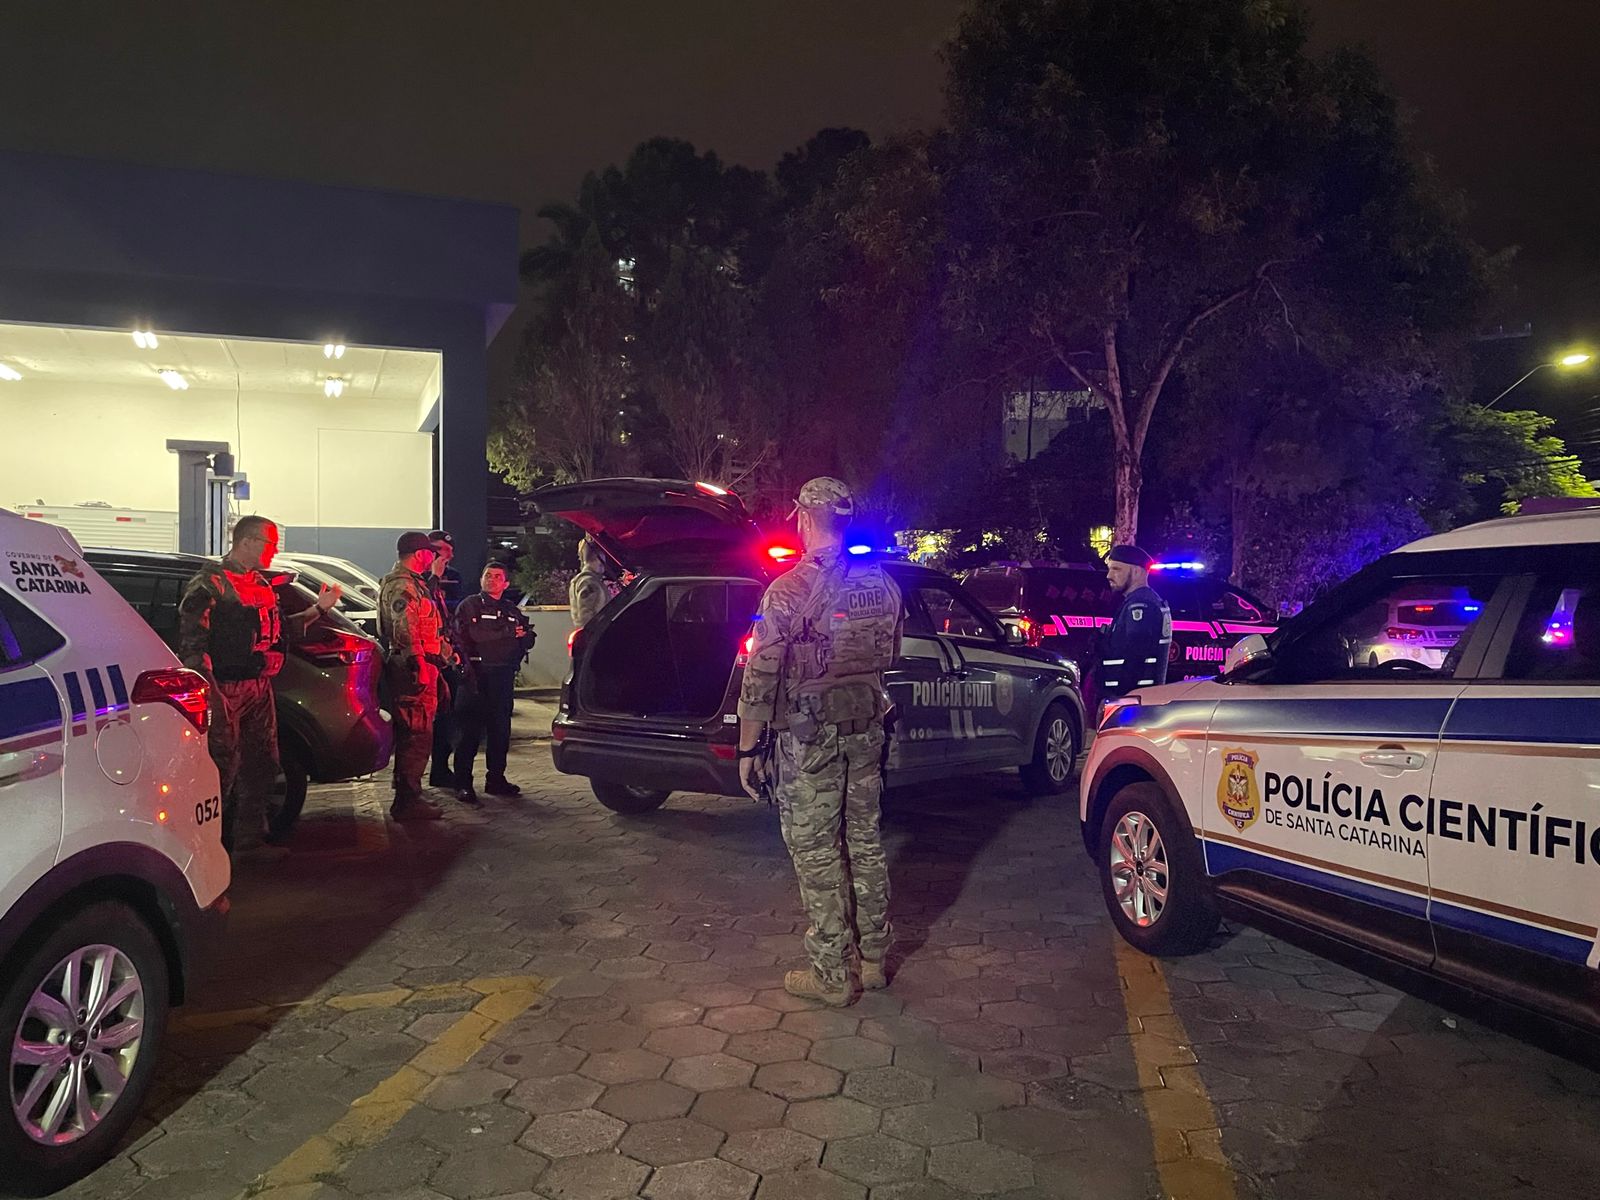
[{"xmin": 8, "ymin": 946, "xmax": 144, "ymax": 1146}]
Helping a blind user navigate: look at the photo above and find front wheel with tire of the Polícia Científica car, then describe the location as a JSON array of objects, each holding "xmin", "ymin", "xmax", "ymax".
[{"xmin": 1094, "ymin": 782, "xmax": 1219, "ymax": 957}]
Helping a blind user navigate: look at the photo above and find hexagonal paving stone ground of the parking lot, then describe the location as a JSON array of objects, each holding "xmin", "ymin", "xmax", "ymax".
[{"xmin": 50, "ymin": 732, "xmax": 1600, "ymax": 1200}]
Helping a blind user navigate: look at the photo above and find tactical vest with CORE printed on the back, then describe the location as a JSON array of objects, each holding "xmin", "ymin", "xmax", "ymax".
[{"xmin": 786, "ymin": 558, "xmax": 899, "ymax": 741}]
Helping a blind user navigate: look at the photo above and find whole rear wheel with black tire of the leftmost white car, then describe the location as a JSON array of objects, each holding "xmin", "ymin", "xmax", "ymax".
[{"xmin": 0, "ymin": 901, "xmax": 170, "ymax": 1195}]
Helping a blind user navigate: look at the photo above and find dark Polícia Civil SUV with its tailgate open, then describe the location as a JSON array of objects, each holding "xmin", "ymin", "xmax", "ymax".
[{"xmin": 533, "ymin": 478, "xmax": 1083, "ymax": 813}]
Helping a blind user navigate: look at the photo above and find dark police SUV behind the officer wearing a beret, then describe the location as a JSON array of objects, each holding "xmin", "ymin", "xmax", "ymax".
[{"xmin": 962, "ymin": 563, "xmax": 1277, "ymax": 694}]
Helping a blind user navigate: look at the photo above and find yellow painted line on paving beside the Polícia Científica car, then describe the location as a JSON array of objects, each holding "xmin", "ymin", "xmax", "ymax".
[{"xmin": 1115, "ymin": 938, "xmax": 1238, "ymax": 1200}]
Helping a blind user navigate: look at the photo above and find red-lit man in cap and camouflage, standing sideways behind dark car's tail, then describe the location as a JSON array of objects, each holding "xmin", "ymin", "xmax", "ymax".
[{"xmin": 378, "ymin": 531, "xmax": 445, "ymax": 821}]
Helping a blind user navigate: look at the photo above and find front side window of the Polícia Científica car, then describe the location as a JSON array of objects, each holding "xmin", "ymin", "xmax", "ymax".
[{"xmin": 1269, "ymin": 576, "xmax": 1501, "ymax": 683}]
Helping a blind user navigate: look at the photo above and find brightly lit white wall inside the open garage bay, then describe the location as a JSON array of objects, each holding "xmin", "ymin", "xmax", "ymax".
[{"xmin": 0, "ymin": 378, "xmax": 434, "ymax": 530}]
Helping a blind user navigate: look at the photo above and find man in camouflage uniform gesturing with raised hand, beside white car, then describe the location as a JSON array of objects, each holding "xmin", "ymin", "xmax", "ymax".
[{"xmin": 178, "ymin": 517, "xmax": 341, "ymax": 858}]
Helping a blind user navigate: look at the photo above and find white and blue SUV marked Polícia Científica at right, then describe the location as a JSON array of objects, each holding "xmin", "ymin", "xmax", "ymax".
[{"xmin": 1082, "ymin": 509, "xmax": 1600, "ymax": 1027}]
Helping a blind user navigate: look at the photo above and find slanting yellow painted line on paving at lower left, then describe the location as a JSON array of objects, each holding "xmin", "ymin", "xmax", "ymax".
[{"xmin": 238, "ymin": 974, "xmax": 546, "ymax": 1200}]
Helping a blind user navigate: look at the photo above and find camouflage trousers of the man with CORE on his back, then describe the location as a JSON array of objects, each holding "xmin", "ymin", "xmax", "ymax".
[{"xmin": 778, "ymin": 722, "xmax": 894, "ymax": 990}]
